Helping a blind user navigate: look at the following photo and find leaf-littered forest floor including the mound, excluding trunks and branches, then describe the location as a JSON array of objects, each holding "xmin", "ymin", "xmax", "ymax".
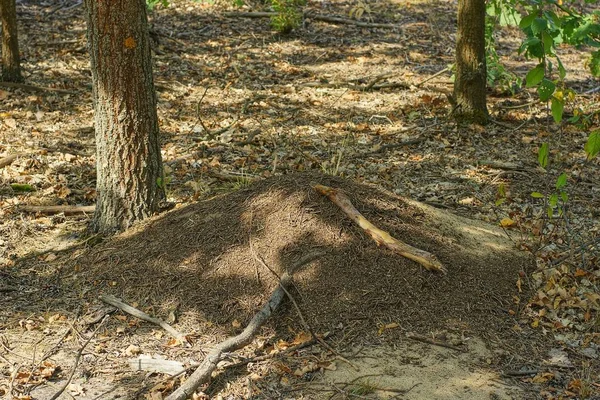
[{"xmin": 0, "ymin": 0, "xmax": 600, "ymax": 400}]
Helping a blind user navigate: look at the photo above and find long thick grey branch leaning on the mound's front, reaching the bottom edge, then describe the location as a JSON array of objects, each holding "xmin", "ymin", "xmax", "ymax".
[{"xmin": 166, "ymin": 253, "xmax": 322, "ymax": 400}]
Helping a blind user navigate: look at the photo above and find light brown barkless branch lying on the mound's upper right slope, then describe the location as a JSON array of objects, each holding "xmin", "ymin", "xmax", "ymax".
[{"xmin": 313, "ymin": 184, "xmax": 447, "ymax": 274}]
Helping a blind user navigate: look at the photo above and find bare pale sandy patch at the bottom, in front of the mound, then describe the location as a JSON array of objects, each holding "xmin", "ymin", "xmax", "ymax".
[{"xmin": 315, "ymin": 339, "xmax": 524, "ymax": 400}]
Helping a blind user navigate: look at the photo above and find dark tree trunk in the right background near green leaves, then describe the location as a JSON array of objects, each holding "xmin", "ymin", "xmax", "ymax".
[{"xmin": 454, "ymin": 0, "xmax": 488, "ymax": 123}]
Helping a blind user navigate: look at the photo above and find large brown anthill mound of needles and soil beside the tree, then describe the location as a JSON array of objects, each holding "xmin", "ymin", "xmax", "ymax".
[{"xmin": 59, "ymin": 174, "xmax": 533, "ymax": 340}]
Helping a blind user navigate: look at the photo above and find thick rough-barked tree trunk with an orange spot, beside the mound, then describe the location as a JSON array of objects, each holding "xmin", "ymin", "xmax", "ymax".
[{"xmin": 85, "ymin": 0, "xmax": 165, "ymax": 232}]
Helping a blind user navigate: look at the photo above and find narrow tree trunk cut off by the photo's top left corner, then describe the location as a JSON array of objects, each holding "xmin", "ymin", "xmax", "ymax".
[{"xmin": 0, "ymin": 0, "xmax": 23, "ymax": 82}]
